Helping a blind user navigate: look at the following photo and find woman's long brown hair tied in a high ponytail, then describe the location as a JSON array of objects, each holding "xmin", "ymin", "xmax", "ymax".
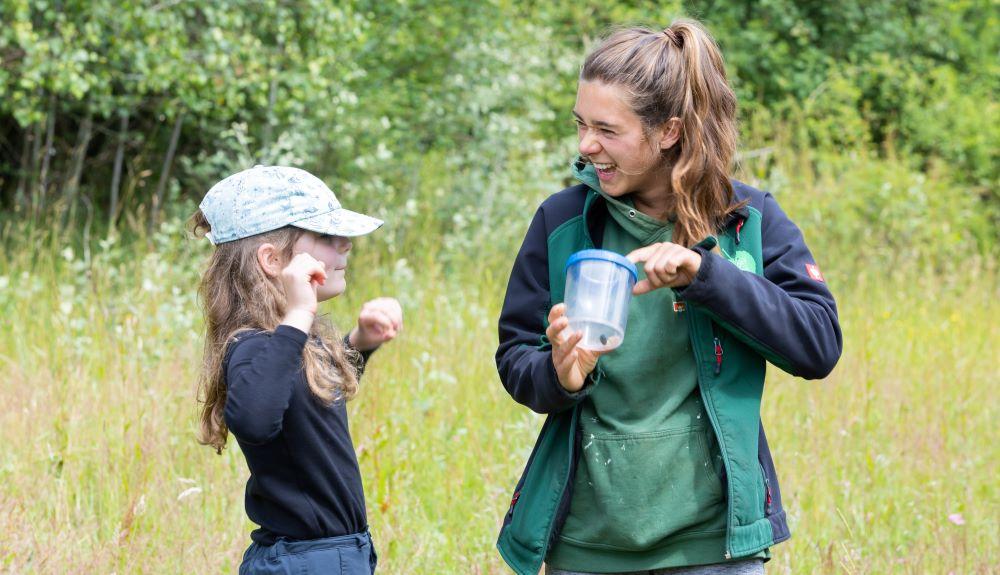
[{"xmin": 580, "ymin": 19, "xmax": 737, "ymax": 247}]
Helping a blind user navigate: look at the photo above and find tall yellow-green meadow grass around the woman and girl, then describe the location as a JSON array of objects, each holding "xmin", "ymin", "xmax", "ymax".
[{"xmin": 0, "ymin": 214, "xmax": 1000, "ymax": 574}]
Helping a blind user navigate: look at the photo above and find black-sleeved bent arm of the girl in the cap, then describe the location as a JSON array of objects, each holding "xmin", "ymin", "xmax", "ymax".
[{"xmin": 225, "ymin": 325, "xmax": 308, "ymax": 445}]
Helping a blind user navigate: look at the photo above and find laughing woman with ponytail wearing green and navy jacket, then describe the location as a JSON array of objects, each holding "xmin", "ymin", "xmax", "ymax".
[{"xmin": 496, "ymin": 20, "xmax": 841, "ymax": 575}]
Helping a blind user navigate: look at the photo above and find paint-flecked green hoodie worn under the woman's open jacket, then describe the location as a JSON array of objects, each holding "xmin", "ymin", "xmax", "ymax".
[{"xmin": 547, "ymin": 192, "xmax": 726, "ymax": 572}]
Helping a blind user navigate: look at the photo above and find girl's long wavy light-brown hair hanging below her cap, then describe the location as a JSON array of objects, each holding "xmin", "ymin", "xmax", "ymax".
[{"xmin": 191, "ymin": 210, "xmax": 358, "ymax": 453}]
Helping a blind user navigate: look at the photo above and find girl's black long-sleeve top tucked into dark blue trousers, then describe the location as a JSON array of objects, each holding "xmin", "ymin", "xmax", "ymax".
[{"xmin": 223, "ymin": 325, "xmax": 369, "ymax": 545}]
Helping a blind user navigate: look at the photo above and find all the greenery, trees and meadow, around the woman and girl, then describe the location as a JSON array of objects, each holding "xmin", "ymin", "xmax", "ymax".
[{"xmin": 0, "ymin": 0, "xmax": 1000, "ymax": 573}]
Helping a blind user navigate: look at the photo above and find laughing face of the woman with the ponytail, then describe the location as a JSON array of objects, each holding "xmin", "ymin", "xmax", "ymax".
[{"xmin": 573, "ymin": 81, "xmax": 678, "ymax": 202}]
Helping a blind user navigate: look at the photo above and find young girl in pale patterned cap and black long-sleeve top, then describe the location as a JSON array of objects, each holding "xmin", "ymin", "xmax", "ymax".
[{"xmin": 193, "ymin": 166, "xmax": 403, "ymax": 575}]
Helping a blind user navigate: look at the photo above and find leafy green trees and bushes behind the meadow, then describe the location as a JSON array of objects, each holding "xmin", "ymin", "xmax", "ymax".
[{"xmin": 0, "ymin": 0, "xmax": 1000, "ymax": 268}]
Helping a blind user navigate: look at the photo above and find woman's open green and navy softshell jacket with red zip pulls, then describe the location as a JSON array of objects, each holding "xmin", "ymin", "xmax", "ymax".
[{"xmin": 496, "ymin": 161, "xmax": 842, "ymax": 575}]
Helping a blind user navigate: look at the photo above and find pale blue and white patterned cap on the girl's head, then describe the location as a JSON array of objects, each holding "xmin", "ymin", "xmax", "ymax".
[{"xmin": 198, "ymin": 166, "xmax": 383, "ymax": 244}]
